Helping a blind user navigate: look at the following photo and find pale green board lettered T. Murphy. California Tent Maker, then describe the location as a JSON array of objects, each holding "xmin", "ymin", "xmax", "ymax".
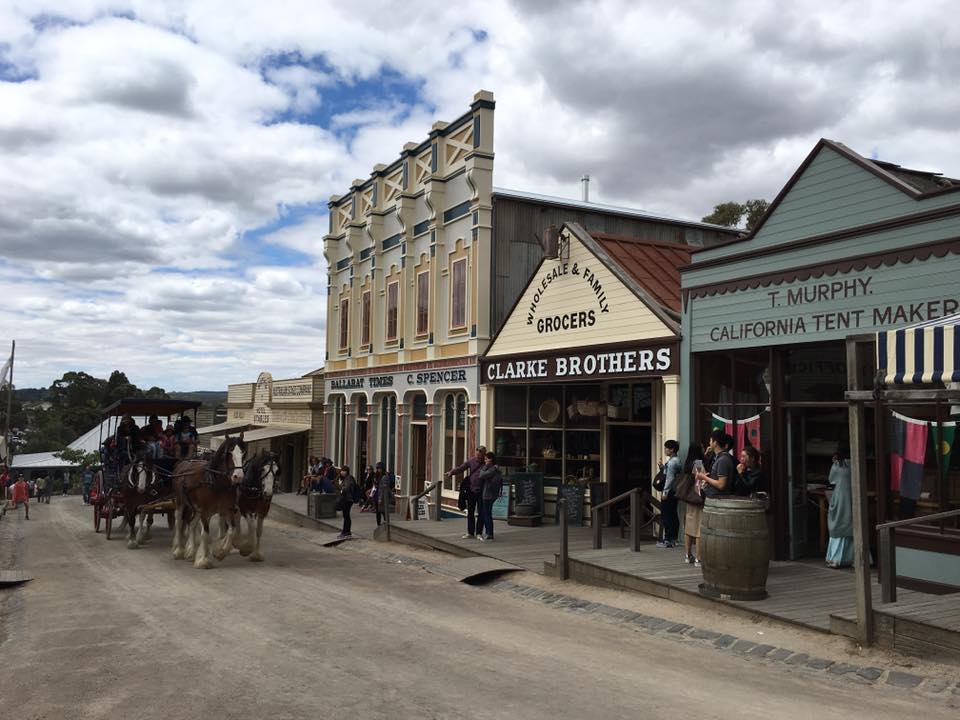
[{"xmin": 688, "ymin": 254, "xmax": 960, "ymax": 352}]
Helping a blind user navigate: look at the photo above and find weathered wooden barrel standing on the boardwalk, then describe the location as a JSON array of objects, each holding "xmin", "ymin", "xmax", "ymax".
[{"xmin": 700, "ymin": 498, "xmax": 770, "ymax": 600}]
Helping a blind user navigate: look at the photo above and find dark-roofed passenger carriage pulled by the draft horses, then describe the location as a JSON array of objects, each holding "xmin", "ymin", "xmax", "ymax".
[{"xmin": 90, "ymin": 398, "xmax": 200, "ymax": 540}]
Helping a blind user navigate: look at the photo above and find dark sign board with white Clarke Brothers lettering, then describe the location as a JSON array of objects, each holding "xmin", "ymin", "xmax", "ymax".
[{"xmin": 480, "ymin": 339, "xmax": 679, "ymax": 384}]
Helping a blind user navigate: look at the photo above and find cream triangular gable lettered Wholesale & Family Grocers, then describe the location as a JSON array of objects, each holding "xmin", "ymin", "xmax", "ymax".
[{"xmin": 487, "ymin": 234, "xmax": 673, "ymax": 356}]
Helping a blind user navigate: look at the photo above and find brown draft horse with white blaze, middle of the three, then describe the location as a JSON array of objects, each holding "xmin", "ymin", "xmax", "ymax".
[{"xmin": 173, "ymin": 433, "xmax": 247, "ymax": 569}]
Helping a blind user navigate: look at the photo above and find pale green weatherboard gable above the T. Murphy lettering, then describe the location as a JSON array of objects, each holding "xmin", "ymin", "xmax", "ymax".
[{"xmin": 696, "ymin": 147, "xmax": 958, "ymax": 261}]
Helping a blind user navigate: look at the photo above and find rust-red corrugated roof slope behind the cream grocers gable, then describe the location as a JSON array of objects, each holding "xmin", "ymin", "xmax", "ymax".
[{"xmin": 590, "ymin": 233, "xmax": 690, "ymax": 312}]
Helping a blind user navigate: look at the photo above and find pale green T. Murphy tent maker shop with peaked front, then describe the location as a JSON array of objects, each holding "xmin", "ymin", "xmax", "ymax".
[{"xmin": 681, "ymin": 140, "xmax": 960, "ymax": 559}]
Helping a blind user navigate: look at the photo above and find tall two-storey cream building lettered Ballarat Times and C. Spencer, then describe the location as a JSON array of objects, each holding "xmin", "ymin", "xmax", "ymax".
[{"xmin": 324, "ymin": 91, "xmax": 731, "ymax": 506}]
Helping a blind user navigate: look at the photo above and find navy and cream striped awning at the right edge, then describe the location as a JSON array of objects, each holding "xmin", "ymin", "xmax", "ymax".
[{"xmin": 877, "ymin": 313, "xmax": 960, "ymax": 385}]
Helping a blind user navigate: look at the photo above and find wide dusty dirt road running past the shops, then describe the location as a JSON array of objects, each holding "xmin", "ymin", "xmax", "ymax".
[{"xmin": 0, "ymin": 498, "xmax": 957, "ymax": 720}]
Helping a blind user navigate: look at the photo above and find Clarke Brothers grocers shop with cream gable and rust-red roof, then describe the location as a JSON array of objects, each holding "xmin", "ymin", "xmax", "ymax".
[{"xmin": 480, "ymin": 223, "xmax": 689, "ymax": 522}]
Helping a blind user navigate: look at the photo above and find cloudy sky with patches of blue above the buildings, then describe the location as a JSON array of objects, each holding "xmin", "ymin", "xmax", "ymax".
[{"xmin": 0, "ymin": 0, "xmax": 960, "ymax": 390}]
